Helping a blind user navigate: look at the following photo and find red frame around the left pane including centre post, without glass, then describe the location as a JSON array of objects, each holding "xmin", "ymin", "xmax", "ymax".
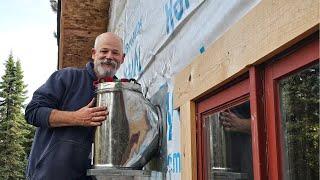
[{"xmin": 196, "ymin": 73, "xmax": 266, "ymax": 180}]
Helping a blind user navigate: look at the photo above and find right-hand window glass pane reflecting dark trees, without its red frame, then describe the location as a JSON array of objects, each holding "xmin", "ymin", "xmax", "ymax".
[{"xmin": 279, "ymin": 63, "xmax": 319, "ymax": 180}]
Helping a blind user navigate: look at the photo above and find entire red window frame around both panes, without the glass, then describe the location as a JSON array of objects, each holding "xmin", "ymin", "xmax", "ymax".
[{"xmin": 196, "ymin": 32, "xmax": 319, "ymax": 180}]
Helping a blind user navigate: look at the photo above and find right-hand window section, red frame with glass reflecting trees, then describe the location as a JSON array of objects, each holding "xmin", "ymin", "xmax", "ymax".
[{"xmin": 265, "ymin": 37, "xmax": 320, "ymax": 180}]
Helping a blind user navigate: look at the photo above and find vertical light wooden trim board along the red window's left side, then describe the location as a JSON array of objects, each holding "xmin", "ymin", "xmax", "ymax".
[{"xmin": 180, "ymin": 101, "xmax": 197, "ymax": 180}]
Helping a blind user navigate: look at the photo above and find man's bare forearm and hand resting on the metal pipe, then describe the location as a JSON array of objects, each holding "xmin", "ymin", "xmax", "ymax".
[{"xmin": 49, "ymin": 98, "xmax": 109, "ymax": 127}]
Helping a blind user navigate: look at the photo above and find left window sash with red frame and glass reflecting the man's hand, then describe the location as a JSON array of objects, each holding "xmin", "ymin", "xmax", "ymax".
[{"xmin": 197, "ymin": 78, "xmax": 253, "ymax": 179}]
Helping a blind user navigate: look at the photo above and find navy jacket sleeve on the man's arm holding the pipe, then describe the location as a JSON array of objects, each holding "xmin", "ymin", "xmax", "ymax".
[{"xmin": 25, "ymin": 70, "xmax": 68, "ymax": 127}]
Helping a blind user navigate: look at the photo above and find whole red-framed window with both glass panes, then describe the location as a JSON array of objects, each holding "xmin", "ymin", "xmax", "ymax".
[{"xmin": 196, "ymin": 32, "xmax": 320, "ymax": 180}]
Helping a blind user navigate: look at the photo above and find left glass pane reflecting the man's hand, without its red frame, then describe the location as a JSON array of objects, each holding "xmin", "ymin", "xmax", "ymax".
[{"xmin": 203, "ymin": 101, "xmax": 253, "ymax": 179}]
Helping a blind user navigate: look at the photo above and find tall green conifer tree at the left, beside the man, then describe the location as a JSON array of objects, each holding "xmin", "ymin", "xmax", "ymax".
[{"xmin": 0, "ymin": 53, "xmax": 31, "ymax": 179}]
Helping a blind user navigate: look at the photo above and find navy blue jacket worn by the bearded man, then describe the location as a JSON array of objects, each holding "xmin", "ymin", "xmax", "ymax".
[{"xmin": 25, "ymin": 62, "xmax": 96, "ymax": 180}]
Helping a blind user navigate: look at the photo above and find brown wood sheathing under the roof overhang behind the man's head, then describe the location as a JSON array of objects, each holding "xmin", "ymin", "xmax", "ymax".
[{"xmin": 59, "ymin": 0, "xmax": 110, "ymax": 69}]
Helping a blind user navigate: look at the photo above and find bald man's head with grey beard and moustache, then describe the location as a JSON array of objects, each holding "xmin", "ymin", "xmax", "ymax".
[{"xmin": 92, "ymin": 32, "xmax": 124, "ymax": 78}]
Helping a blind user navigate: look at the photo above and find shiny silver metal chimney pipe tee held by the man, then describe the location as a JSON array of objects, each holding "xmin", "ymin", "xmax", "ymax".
[{"xmin": 93, "ymin": 82, "xmax": 160, "ymax": 169}]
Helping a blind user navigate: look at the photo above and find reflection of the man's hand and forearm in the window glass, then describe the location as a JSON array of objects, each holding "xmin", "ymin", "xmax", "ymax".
[{"xmin": 220, "ymin": 110, "xmax": 251, "ymax": 134}]
